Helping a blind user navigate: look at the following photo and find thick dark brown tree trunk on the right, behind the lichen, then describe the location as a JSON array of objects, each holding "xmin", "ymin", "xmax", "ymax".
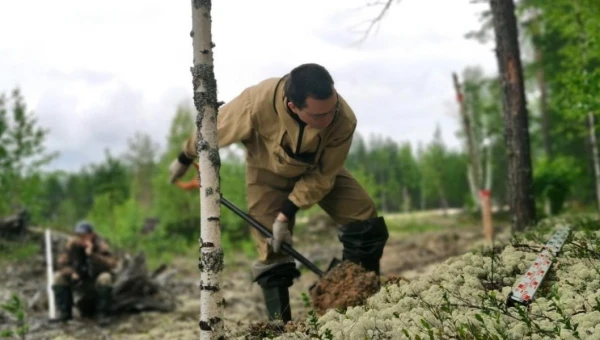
[{"xmin": 490, "ymin": 0, "xmax": 536, "ymax": 232}]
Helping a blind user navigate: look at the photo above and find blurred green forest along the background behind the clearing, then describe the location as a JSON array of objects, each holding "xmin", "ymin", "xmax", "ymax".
[{"xmin": 0, "ymin": 0, "xmax": 600, "ymax": 266}]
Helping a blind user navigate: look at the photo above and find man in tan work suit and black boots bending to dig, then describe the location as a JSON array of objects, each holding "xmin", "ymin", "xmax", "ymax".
[{"xmin": 169, "ymin": 64, "xmax": 388, "ymax": 322}]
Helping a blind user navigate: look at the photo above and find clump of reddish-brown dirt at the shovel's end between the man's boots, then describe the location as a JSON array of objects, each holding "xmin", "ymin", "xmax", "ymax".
[{"xmin": 311, "ymin": 261, "xmax": 381, "ymax": 315}]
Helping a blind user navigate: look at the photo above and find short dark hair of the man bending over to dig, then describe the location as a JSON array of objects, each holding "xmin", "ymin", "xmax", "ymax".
[{"xmin": 285, "ymin": 63, "xmax": 333, "ymax": 109}]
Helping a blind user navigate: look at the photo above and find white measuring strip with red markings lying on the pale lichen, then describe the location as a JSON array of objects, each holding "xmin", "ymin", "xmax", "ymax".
[{"xmin": 507, "ymin": 227, "xmax": 570, "ymax": 305}]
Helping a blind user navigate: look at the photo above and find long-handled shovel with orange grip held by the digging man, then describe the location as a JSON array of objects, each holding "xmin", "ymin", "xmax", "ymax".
[{"xmin": 175, "ymin": 163, "xmax": 342, "ymax": 282}]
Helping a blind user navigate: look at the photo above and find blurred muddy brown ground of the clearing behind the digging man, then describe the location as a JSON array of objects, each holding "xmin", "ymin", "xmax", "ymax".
[{"xmin": 0, "ymin": 215, "xmax": 508, "ymax": 340}]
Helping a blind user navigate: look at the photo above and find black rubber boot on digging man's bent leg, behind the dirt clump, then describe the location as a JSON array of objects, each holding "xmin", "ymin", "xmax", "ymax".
[{"xmin": 338, "ymin": 216, "xmax": 389, "ymax": 275}]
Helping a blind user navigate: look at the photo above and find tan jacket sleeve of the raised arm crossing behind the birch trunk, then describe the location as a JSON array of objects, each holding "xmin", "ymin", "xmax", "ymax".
[{"xmin": 182, "ymin": 88, "xmax": 253, "ymax": 160}]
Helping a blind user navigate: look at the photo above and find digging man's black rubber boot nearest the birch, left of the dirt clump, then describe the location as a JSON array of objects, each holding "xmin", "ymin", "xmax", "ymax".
[{"xmin": 256, "ymin": 263, "xmax": 300, "ymax": 323}]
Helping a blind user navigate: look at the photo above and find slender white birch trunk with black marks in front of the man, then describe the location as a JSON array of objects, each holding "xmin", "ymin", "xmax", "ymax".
[{"xmin": 190, "ymin": 0, "xmax": 224, "ymax": 339}]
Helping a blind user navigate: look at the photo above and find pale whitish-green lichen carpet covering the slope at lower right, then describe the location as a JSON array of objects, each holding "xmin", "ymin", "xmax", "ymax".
[{"xmin": 278, "ymin": 216, "xmax": 600, "ymax": 339}]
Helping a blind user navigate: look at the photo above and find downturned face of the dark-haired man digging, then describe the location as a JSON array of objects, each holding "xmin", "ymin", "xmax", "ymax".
[{"xmin": 288, "ymin": 91, "xmax": 340, "ymax": 129}]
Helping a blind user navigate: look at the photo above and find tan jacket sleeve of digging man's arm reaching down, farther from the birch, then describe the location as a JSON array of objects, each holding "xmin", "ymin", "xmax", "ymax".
[{"xmin": 284, "ymin": 124, "xmax": 356, "ymax": 211}]
